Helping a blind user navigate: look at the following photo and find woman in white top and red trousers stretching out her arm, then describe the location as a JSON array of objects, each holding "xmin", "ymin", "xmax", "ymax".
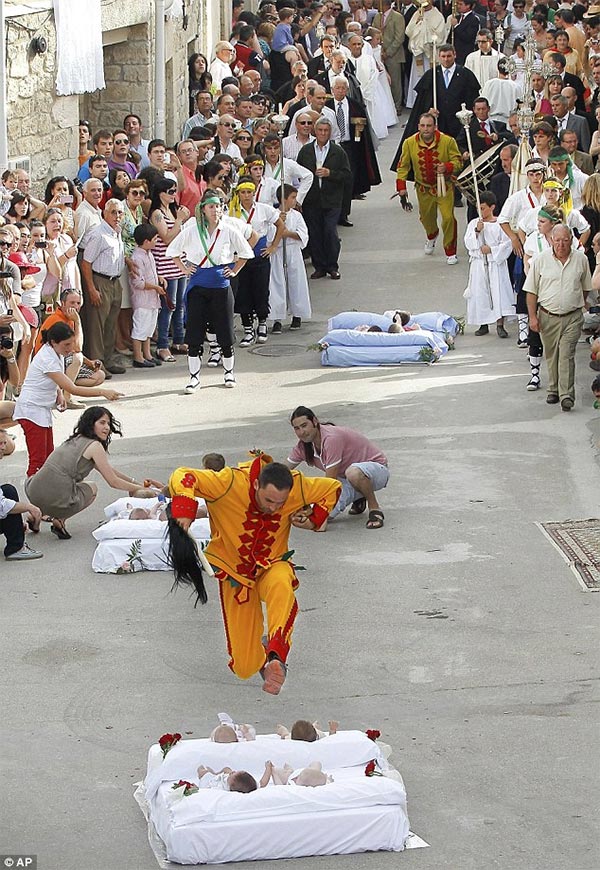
[{"xmin": 13, "ymin": 323, "xmax": 122, "ymax": 477}]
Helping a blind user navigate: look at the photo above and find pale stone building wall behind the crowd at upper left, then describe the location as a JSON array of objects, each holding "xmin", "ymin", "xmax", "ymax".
[{"xmin": 6, "ymin": 0, "xmax": 231, "ymax": 191}]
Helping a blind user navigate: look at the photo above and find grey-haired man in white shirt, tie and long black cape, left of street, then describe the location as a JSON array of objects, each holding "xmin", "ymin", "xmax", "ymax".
[{"xmin": 327, "ymin": 76, "xmax": 381, "ymax": 227}]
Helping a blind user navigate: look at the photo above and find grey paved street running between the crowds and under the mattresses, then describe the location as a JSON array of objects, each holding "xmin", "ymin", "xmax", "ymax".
[{"xmin": 0, "ymin": 133, "xmax": 600, "ymax": 870}]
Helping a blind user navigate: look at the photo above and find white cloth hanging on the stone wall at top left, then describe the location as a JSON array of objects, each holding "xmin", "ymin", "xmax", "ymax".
[{"xmin": 54, "ymin": 0, "xmax": 105, "ymax": 96}]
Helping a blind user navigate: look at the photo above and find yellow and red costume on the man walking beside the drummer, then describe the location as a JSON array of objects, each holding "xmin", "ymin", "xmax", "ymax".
[{"xmin": 396, "ymin": 130, "xmax": 463, "ymax": 257}]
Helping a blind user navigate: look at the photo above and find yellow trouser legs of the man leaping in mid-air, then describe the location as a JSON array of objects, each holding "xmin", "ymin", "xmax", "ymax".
[{"xmin": 219, "ymin": 562, "xmax": 298, "ymax": 680}]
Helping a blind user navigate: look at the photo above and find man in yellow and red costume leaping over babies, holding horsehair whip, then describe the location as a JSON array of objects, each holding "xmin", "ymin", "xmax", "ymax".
[{"xmin": 169, "ymin": 454, "xmax": 341, "ymax": 695}]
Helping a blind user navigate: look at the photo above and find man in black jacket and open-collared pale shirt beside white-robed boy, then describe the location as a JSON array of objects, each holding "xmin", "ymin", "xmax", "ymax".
[{"xmin": 297, "ymin": 116, "xmax": 351, "ymax": 280}]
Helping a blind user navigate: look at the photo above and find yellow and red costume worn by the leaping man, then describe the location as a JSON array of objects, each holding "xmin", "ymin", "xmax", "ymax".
[{"xmin": 169, "ymin": 453, "xmax": 341, "ymax": 680}]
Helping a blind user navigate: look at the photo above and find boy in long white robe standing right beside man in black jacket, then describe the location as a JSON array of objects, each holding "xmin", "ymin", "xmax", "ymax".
[{"xmin": 269, "ymin": 184, "xmax": 312, "ymax": 335}]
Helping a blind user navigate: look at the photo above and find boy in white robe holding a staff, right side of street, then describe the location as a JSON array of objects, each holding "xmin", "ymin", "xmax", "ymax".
[{"xmin": 464, "ymin": 191, "xmax": 515, "ymax": 338}]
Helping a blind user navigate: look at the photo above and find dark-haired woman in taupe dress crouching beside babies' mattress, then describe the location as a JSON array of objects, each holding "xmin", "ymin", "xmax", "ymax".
[{"xmin": 25, "ymin": 405, "xmax": 154, "ymax": 540}]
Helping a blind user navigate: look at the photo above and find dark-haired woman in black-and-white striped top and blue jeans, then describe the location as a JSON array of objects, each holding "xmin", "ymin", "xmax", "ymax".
[{"xmin": 149, "ymin": 178, "xmax": 190, "ymax": 362}]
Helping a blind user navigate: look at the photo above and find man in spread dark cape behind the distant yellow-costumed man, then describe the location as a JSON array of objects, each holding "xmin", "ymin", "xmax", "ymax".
[{"xmin": 391, "ymin": 44, "xmax": 480, "ymax": 172}]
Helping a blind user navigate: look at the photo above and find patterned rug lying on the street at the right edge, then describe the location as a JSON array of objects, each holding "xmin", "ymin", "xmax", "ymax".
[{"xmin": 536, "ymin": 519, "xmax": 600, "ymax": 592}]
